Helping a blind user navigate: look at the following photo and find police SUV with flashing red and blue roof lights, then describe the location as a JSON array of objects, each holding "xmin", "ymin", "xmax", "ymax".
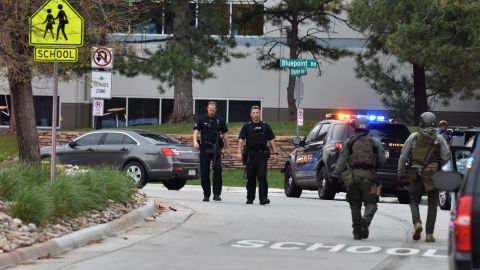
[{"xmin": 282, "ymin": 114, "xmax": 410, "ymax": 203}]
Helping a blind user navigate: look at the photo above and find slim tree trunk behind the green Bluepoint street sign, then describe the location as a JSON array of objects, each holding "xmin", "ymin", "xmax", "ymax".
[{"xmin": 287, "ymin": 14, "xmax": 299, "ymax": 120}]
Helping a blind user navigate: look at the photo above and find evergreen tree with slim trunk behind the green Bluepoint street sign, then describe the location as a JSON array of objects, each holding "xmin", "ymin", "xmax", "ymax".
[{"xmin": 255, "ymin": 0, "xmax": 350, "ymax": 120}]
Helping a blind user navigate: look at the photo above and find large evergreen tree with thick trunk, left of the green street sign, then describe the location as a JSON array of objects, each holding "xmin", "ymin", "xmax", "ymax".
[{"xmin": 116, "ymin": 0, "xmax": 243, "ymax": 123}]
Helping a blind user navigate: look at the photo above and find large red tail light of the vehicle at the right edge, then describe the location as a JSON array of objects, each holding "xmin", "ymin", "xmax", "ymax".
[{"xmin": 453, "ymin": 195, "xmax": 473, "ymax": 252}]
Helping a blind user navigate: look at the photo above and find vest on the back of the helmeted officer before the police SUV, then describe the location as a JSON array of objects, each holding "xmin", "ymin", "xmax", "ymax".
[{"xmin": 348, "ymin": 135, "xmax": 378, "ymax": 169}]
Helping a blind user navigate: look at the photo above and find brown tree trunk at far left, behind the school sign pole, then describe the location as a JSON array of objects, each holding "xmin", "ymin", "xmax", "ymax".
[{"xmin": 7, "ymin": 29, "xmax": 40, "ymax": 163}]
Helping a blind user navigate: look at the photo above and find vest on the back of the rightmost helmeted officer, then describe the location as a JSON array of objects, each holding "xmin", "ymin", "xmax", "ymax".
[{"xmin": 410, "ymin": 132, "xmax": 440, "ymax": 166}]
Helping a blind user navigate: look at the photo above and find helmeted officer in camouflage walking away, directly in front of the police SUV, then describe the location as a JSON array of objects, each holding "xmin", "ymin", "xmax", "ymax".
[{"xmin": 330, "ymin": 116, "xmax": 385, "ymax": 240}]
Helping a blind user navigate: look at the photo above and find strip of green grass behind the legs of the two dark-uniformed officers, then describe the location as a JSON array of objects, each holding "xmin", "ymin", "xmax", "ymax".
[{"xmin": 187, "ymin": 169, "xmax": 283, "ymax": 188}]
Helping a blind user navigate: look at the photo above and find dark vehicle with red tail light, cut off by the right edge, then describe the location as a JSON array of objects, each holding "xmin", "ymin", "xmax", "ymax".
[{"xmin": 433, "ymin": 138, "xmax": 480, "ymax": 269}]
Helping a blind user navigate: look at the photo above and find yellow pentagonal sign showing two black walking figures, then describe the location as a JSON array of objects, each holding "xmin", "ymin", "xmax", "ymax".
[{"xmin": 29, "ymin": 0, "xmax": 83, "ymax": 47}]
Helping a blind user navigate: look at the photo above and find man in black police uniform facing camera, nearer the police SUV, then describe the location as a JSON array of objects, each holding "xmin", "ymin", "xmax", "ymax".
[{"xmin": 237, "ymin": 106, "xmax": 277, "ymax": 205}]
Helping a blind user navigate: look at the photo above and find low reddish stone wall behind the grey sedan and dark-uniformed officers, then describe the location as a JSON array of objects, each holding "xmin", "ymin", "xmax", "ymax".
[{"xmin": 38, "ymin": 131, "xmax": 293, "ymax": 169}]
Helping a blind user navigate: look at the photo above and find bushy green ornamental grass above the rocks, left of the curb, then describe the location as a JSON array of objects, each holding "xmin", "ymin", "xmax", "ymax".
[{"xmin": 0, "ymin": 164, "xmax": 137, "ymax": 225}]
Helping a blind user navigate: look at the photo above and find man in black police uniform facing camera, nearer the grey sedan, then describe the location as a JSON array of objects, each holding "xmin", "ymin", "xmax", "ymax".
[{"xmin": 193, "ymin": 101, "xmax": 229, "ymax": 202}]
